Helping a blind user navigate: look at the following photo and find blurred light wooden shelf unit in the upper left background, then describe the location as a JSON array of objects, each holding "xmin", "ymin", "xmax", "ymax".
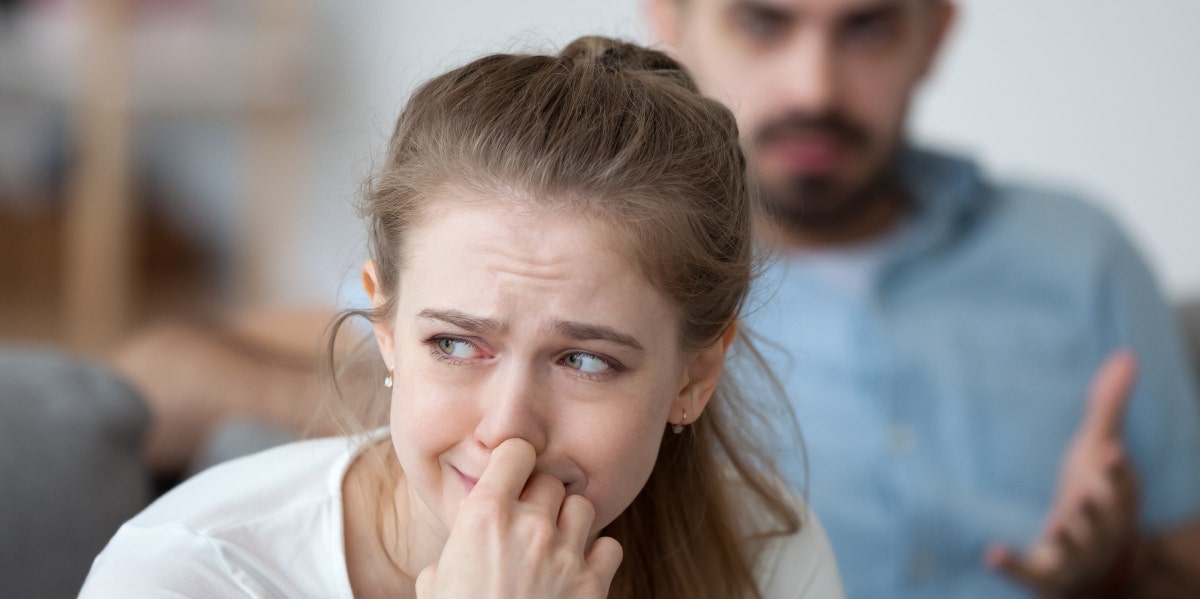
[{"xmin": 0, "ymin": 0, "xmax": 311, "ymax": 353}]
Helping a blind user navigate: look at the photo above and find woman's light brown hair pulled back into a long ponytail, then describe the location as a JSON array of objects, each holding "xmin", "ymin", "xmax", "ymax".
[{"xmin": 324, "ymin": 37, "xmax": 800, "ymax": 598}]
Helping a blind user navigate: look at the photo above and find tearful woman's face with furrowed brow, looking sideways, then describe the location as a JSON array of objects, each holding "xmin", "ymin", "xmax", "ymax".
[{"xmin": 366, "ymin": 192, "xmax": 720, "ymax": 535}]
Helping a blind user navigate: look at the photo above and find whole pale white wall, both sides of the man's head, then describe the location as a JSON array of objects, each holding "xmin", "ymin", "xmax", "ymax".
[{"xmin": 292, "ymin": 0, "xmax": 1200, "ymax": 304}]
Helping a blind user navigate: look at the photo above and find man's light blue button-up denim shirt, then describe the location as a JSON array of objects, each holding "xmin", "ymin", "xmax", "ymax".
[{"xmin": 745, "ymin": 150, "xmax": 1200, "ymax": 599}]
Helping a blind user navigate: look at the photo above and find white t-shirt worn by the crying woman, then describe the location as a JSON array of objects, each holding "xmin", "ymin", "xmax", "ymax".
[{"xmin": 79, "ymin": 437, "xmax": 842, "ymax": 599}]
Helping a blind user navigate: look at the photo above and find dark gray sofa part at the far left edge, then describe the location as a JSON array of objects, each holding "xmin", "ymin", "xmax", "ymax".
[{"xmin": 0, "ymin": 347, "xmax": 150, "ymax": 598}]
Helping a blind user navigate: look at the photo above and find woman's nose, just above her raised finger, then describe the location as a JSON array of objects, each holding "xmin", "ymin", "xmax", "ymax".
[{"xmin": 475, "ymin": 364, "xmax": 546, "ymax": 454}]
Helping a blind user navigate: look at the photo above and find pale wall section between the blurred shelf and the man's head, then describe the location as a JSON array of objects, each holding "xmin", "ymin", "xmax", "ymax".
[{"xmin": 290, "ymin": 0, "xmax": 640, "ymax": 303}]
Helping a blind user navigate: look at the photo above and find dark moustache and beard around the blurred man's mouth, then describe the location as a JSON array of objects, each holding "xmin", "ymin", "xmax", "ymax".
[{"xmin": 752, "ymin": 113, "xmax": 900, "ymax": 233}]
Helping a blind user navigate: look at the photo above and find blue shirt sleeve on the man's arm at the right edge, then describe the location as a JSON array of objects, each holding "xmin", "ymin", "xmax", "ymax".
[{"xmin": 1102, "ymin": 218, "xmax": 1200, "ymax": 531}]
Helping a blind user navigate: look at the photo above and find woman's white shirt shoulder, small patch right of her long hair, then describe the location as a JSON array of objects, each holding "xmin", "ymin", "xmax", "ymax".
[{"xmin": 757, "ymin": 509, "xmax": 844, "ymax": 599}]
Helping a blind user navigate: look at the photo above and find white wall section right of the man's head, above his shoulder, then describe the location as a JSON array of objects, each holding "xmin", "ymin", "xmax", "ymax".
[{"xmin": 913, "ymin": 0, "xmax": 1200, "ymax": 298}]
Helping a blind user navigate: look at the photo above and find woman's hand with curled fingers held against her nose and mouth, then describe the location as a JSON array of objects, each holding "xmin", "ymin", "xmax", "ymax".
[{"xmin": 416, "ymin": 439, "xmax": 622, "ymax": 599}]
